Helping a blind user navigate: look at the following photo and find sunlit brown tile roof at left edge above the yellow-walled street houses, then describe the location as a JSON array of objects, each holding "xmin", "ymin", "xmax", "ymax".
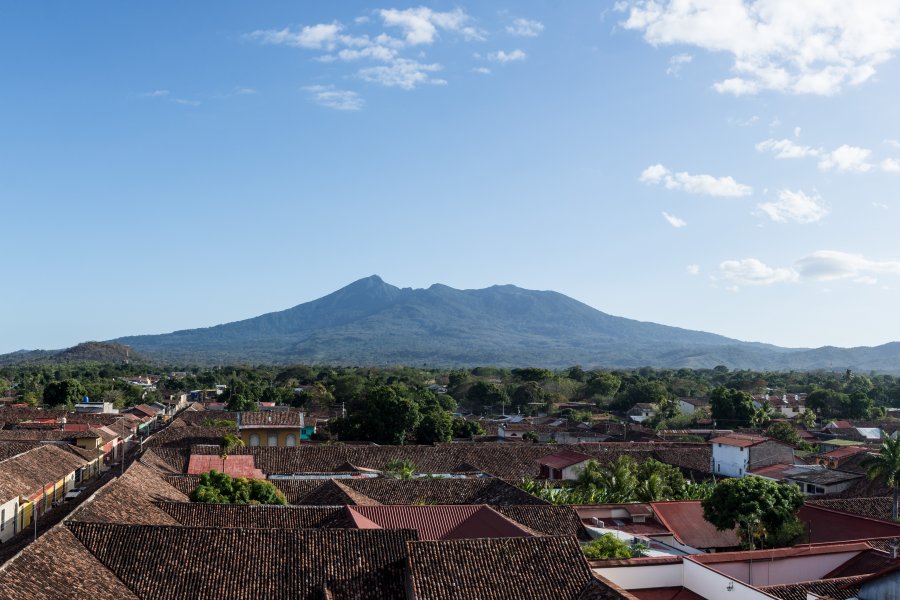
[{"xmin": 0, "ymin": 444, "xmax": 87, "ymax": 504}]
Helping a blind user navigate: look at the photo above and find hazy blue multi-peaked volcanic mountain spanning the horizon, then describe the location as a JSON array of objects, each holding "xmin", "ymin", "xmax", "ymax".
[{"xmin": 0, "ymin": 275, "xmax": 900, "ymax": 372}]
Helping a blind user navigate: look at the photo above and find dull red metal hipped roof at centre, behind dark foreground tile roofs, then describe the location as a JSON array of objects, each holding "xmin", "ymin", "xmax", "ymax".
[{"xmin": 347, "ymin": 504, "xmax": 534, "ymax": 540}]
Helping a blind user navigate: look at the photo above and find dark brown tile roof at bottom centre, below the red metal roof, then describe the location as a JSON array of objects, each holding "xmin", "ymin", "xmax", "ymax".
[{"xmin": 408, "ymin": 537, "xmax": 593, "ymax": 600}]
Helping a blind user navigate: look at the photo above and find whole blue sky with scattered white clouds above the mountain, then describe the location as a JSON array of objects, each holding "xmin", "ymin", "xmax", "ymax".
[{"xmin": 0, "ymin": 0, "xmax": 900, "ymax": 352}]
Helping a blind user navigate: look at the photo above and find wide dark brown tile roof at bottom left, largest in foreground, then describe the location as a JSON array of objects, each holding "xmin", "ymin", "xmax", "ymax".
[{"xmin": 69, "ymin": 522, "xmax": 415, "ymax": 600}]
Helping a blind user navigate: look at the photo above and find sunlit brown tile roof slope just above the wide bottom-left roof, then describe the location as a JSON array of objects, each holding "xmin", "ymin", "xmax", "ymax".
[{"xmin": 69, "ymin": 462, "xmax": 188, "ymax": 525}]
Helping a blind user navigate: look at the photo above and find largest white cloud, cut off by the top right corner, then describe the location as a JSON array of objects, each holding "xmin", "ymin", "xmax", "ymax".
[{"xmin": 616, "ymin": 0, "xmax": 900, "ymax": 95}]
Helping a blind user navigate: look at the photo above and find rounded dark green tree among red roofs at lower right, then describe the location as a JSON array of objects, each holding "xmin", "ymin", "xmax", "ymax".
[{"xmin": 703, "ymin": 475, "xmax": 804, "ymax": 548}]
